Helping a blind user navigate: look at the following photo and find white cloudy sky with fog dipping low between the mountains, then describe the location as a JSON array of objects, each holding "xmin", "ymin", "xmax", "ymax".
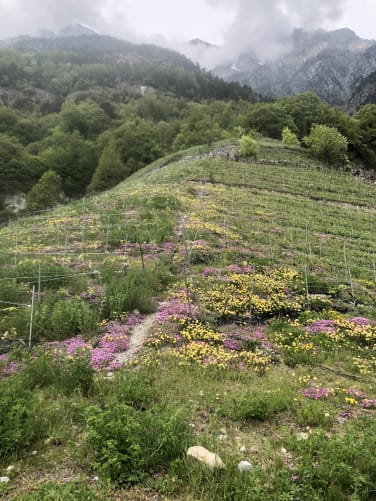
[{"xmin": 0, "ymin": 0, "xmax": 369, "ymax": 63}]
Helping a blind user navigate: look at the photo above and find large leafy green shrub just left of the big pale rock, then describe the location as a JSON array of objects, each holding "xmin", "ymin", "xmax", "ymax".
[{"xmin": 86, "ymin": 401, "xmax": 188, "ymax": 485}]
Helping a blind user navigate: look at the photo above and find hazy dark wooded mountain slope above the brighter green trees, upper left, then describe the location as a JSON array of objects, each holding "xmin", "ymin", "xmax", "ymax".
[{"xmin": 0, "ymin": 30, "xmax": 257, "ymax": 111}]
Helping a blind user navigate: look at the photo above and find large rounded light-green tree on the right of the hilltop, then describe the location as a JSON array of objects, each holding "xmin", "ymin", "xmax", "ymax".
[{"xmin": 303, "ymin": 124, "xmax": 348, "ymax": 165}]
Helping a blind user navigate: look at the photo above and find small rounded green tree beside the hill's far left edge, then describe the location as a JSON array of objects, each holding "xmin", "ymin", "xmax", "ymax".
[{"xmin": 26, "ymin": 170, "xmax": 62, "ymax": 211}]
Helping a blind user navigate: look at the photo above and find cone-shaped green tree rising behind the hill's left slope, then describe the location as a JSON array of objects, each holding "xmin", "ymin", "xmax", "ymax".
[{"xmin": 87, "ymin": 139, "xmax": 130, "ymax": 193}]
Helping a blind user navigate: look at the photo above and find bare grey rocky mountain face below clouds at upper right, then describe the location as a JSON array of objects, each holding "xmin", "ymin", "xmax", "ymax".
[{"xmin": 214, "ymin": 28, "xmax": 376, "ymax": 109}]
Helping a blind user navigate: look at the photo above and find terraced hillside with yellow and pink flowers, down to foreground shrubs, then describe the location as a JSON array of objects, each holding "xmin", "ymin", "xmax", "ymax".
[{"xmin": 0, "ymin": 140, "xmax": 376, "ymax": 501}]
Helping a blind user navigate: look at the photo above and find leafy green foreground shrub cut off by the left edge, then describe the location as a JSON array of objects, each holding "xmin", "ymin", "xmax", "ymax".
[{"xmin": 0, "ymin": 376, "xmax": 40, "ymax": 460}]
